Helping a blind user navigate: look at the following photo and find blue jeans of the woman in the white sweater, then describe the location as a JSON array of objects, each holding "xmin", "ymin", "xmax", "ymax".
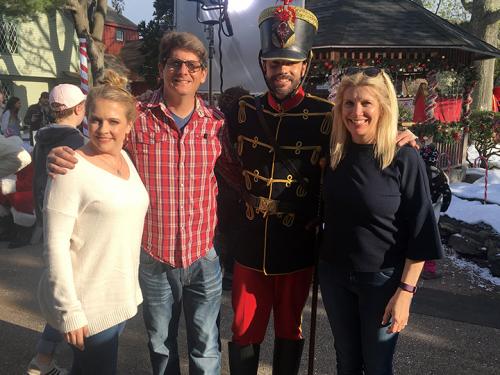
[{"xmin": 70, "ymin": 322, "xmax": 125, "ymax": 375}]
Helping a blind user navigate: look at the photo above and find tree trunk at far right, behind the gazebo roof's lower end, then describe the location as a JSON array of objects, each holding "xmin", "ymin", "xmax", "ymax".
[{"xmin": 470, "ymin": 0, "xmax": 500, "ymax": 110}]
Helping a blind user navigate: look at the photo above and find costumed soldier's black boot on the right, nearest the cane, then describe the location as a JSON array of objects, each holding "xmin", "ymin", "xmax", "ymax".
[{"xmin": 273, "ymin": 338, "xmax": 304, "ymax": 375}]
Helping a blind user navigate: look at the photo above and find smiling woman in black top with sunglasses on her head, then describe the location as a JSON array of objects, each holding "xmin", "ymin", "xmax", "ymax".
[{"xmin": 319, "ymin": 67, "xmax": 442, "ymax": 375}]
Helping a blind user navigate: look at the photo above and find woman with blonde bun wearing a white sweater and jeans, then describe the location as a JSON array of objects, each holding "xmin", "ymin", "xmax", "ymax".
[{"xmin": 38, "ymin": 71, "xmax": 149, "ymax": 375}]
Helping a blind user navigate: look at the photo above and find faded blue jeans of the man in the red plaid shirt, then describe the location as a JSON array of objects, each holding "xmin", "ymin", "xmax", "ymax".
[{"xmin": 139, "ymin": 249, "xmax": 222, "ymax": 375}]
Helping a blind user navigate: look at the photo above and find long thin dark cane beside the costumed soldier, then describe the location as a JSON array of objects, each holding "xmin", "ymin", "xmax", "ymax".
[{"xmin": 307, "ymin": 158, "xmax": 327, "ymax": 375}]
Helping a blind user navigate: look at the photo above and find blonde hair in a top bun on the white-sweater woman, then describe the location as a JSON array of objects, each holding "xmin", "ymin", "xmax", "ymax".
[{"xmin": 86, "ymin": 69, "xmax": 137, "ymax": 122}]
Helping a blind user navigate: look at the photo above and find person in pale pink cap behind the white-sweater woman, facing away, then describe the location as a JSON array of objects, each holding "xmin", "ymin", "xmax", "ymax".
[{"xmin": 27, "ymin": 83, "xmax": 86, "ymax": 375}]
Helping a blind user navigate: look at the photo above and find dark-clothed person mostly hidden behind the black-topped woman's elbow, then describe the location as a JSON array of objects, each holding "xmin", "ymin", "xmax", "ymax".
[{"xmin": 420, "ymin": 145, "xmax": 451, "ymax": 280}]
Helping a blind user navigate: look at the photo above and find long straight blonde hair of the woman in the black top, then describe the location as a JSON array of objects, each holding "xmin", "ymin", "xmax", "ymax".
[{"xmin": 330, "ymin": 70, "xmax": 399, "ymax": 169}]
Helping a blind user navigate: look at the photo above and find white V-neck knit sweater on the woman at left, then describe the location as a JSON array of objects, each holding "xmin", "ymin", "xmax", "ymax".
[{"xmin": 38, "ymin": 151, "xmax": 149, "ymax": 335}]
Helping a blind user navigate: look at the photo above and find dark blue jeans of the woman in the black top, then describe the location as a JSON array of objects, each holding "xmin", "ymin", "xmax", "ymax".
[{"xmin": 319, "ymin": 261, "xmax": 401, "ymax": 375}]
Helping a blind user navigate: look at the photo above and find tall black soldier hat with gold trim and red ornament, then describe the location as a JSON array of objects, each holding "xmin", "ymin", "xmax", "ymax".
[{"xmin": 259, "ymin": 0, "xmax": 318, "ymax": 61}]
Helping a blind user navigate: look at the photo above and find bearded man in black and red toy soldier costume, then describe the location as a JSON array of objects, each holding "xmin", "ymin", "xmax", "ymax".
[{"xmin": 223, "ymin": 0, "xmax": 333, "ymax": 375}]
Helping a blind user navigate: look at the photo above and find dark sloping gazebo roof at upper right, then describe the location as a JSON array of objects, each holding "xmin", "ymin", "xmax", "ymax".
[{"xmin": 306, "ymin": 0, "xmax": 500, "ymax": 60}]
